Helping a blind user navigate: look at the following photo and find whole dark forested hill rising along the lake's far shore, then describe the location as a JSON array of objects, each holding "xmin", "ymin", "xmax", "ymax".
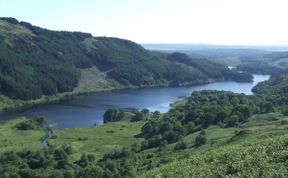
[{"xmin": 0, "ymin": 18, "xmax": 251, "ymax": 100}]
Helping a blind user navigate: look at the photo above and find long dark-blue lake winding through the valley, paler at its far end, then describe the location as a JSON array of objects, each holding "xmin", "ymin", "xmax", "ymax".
[{"xmin": 1, "ymin": 75, "xmax": 269, "ymax": 129}]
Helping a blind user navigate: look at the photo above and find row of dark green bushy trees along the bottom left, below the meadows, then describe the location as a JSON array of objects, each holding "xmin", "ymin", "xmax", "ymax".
[{"xmin": 0, "ymin": 140, "xmax": 143, "ymax": 178}]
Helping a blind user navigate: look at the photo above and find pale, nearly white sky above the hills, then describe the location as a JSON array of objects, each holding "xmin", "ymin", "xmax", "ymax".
[{"xmin": 0, "ymin": 0, "xmax": 288, "ymax": 45}]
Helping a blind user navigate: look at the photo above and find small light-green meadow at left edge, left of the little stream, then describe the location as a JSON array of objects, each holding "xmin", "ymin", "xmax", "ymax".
[{"xmin": 0, "ymin": 118, "xmax": 45, "ymax": 154}]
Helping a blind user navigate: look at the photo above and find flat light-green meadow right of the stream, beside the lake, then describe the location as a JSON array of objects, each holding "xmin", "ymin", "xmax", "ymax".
[{"xmin": 49, "ymin": 121, "xmax": 144, "ymax": 161}]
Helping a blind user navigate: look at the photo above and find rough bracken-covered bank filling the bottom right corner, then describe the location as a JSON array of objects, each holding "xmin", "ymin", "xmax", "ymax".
[{"xmin": 141, "ymin": 135, "xmax": 288, "ymax": 177}]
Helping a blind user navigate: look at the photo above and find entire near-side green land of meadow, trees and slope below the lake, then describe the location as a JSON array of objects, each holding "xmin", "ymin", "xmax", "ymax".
[{"xmin": 0, "ymin": 71, "xmax": 288, "ymax": 178}]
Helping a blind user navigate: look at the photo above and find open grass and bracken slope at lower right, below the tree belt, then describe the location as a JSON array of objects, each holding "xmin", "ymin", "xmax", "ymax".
[{"xmin": 140, "ymin": 113, "xmax": 288, "ymax": 177}]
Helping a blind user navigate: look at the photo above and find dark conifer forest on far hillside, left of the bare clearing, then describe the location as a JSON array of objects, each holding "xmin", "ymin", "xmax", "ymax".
[{"xmin": 0, "ymin": 19, "xmax": 79, "ymax": 100}]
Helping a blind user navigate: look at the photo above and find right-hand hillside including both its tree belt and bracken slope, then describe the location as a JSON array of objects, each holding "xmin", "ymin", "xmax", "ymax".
[{"xmin": 140, "ymin": 76, "xmax": 288, "ymax": 177}]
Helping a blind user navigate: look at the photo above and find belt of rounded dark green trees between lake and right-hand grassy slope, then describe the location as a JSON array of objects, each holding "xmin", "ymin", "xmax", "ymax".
[{"xmin": 142, "ymin": 91, "xmax": 275, "ymax": 149}]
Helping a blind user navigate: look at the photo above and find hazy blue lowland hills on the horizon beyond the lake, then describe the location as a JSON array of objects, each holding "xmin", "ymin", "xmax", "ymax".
[{"xmin": 143, "ymin": 44, "xmax": 288, "ymax": 75}]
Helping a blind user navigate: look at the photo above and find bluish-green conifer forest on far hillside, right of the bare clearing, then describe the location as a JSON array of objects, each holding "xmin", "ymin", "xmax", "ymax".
[{"xmin": 88, "ymin": 37, "xmax": 213, "ymax": 86}]
